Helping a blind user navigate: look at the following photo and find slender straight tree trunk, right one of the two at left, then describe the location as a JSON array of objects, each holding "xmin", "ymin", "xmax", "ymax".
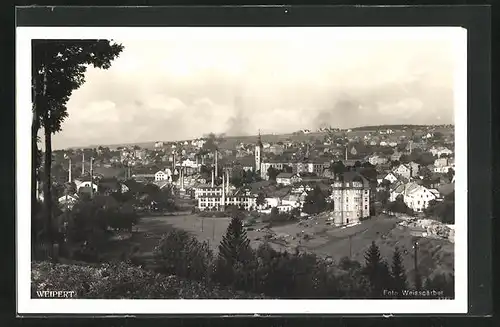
[{"xmin": 43, "ymin": 122, "xmax": 54, "ymax": 244}]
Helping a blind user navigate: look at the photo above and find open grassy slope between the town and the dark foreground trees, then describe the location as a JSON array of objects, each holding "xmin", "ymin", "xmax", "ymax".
[{"xmin": 96, "ymin": 213, "xmax": 454, "ymax": 282}]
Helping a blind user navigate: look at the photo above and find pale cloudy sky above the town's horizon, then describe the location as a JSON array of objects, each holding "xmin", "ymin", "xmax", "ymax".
[{"xmin": 48, "ymin": 27, "xmax": 457, "ymax": 149}]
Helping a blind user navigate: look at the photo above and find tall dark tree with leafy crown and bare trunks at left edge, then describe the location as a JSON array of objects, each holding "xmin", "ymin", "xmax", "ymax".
[{"xmin": 32, "ymin": 40, "xmax": 123, "ymax": 251}]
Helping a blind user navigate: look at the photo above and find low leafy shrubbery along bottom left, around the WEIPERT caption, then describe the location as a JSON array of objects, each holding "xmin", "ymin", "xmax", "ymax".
[{"xmin": 31, "ymin": 262, "xmax": 262, "ymax": 299}]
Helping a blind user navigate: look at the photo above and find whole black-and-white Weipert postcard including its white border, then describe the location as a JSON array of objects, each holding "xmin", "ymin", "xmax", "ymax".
[{"xmin": 16, "ymin": 22, "xmax": 467, "ymax": 314}]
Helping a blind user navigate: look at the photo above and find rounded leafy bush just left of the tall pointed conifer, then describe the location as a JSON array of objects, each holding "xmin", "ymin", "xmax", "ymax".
[{"xmin": 155, "ymin": 230, "xmax": 213, "ymax": 280}]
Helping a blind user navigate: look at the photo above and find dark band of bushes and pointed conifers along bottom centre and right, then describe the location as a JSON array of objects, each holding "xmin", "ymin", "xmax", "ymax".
[{"xmin": 152, "ymin": 218, "xmax": 454, "ymax": 299}]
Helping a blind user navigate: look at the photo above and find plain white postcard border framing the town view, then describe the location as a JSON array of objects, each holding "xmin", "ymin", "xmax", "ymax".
[{"xmin": 16, "ymin": 27, "xmax": 468, "ymax": 315}]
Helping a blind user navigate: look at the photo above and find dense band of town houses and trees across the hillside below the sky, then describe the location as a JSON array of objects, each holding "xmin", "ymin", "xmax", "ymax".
[{"xmin": 48, "ymin": 125, "xmax": 456, "ymax": 225}]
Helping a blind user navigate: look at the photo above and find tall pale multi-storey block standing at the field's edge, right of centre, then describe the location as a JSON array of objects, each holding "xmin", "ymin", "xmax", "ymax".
[{"xmin": 330, "ymin": 172, "xmax": 370, "ymax": 225}]
